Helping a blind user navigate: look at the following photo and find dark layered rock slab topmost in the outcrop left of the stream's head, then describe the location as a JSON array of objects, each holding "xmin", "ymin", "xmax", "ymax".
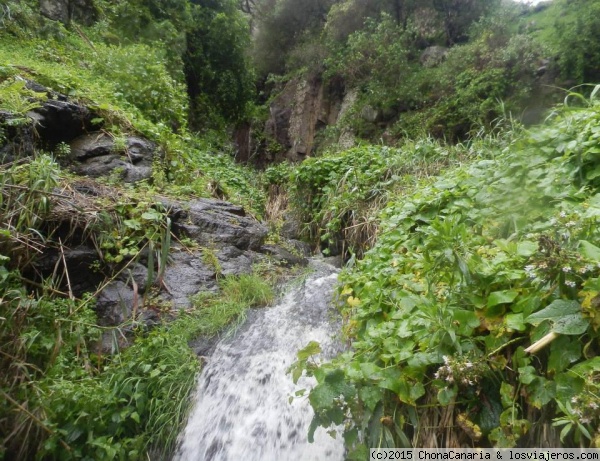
[{"xmin": 174, "ymin": 199, "xmax": 267, "ymax": 250}]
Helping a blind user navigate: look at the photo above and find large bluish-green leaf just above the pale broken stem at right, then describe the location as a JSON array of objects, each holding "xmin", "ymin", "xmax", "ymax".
[{"xmin": 525, "ymin": 299, "xmax": 589, "ymax": 335}]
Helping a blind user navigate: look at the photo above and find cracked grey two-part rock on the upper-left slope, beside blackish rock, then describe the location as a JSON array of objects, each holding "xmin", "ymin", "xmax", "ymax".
[{"xmin": 70, "ymin": 132, "xmax": 158, "ymax": 182}]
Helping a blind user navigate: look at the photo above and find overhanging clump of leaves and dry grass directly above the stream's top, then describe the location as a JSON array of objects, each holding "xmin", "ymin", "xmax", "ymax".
[{"xmin": 265, "ymin": 139, "xmax": 471, "ymax": 256}]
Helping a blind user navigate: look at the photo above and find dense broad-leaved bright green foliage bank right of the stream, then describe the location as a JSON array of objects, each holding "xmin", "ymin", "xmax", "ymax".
[{"xmin": 296, "ymin": 86, "xmax": 600, "ymax": 450}]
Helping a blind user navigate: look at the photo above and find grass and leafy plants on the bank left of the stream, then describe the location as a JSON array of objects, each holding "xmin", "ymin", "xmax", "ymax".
[{"xmin": 0, "ymin": 266, "xmax": 273, "ymax": 460}]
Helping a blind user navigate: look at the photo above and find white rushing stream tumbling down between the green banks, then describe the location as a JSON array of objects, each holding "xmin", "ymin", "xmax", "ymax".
[{"xmin": 174, "ymin": 261, "xmax": 344, "ymax": 461}]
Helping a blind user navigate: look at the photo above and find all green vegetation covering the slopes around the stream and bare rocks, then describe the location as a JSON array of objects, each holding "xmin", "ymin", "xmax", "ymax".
[{"xmin": 0, "ymin": 0, "xmax": 600, "ymax": 460}]
